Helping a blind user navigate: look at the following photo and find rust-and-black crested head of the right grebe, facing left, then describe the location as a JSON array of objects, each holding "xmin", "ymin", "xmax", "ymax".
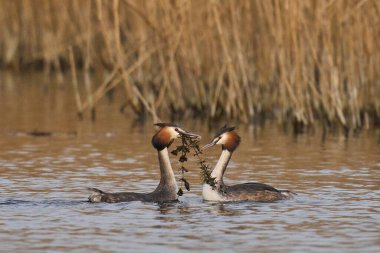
[{"xmin": 202, "ymin": 125, "xmax": 240, "ymax": 152}]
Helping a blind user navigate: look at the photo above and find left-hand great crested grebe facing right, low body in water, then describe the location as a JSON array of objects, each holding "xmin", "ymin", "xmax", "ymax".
[{"xmin": 88, "ymin": 123, "xmax": 200, "ymax": 203}]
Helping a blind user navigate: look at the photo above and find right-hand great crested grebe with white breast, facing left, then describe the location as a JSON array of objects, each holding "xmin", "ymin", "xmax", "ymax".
[{"xmin": 202, "ymin": 125, "xmax": 292, "ymax": 202}]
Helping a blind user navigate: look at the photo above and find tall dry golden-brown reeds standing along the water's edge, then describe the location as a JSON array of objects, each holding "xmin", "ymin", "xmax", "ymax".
[{"xmin": 0, "ymin": 0, "xmax": 380, "ymax": 130}]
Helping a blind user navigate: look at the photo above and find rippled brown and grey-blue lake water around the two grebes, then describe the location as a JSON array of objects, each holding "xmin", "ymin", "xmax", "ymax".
[{"xmin": 0, "ymin": 73, "xmax": 380, "ymax": 253}]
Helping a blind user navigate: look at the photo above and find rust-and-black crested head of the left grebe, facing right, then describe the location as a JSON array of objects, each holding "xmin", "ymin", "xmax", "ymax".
[{"xmin": 152, "ymin": 123, "xmax": 201, "ymax": 151}]
